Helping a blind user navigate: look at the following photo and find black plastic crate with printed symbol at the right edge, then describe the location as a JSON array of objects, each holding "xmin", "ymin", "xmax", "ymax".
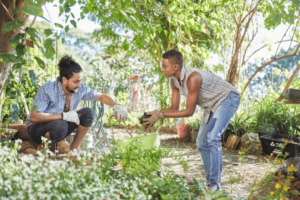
[{"xmin": 260, "ymin": 134, "xmax": 300, "ymax": 159}]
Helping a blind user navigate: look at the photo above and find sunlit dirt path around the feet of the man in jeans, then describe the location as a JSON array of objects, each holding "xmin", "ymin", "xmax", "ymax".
[{"xmin": 107, "ymin": 128, "xmax": 300, "ymax": 199}]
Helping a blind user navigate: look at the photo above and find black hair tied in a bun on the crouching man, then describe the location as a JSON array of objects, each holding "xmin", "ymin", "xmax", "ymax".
[{"xmin": 57, "ymin": 56, "xmax": 82, "ymax": 82}]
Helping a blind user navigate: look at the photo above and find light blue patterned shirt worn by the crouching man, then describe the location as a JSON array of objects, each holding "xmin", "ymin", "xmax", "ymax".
[{"xmin": 25, "ymin": 79, "xmax": 100, "ymax": 126}]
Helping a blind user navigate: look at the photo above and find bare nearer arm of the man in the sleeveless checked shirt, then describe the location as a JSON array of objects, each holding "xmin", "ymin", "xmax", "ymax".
[{"xmin": 163, "ymin": 72, "xmax": 202, "ymax": 118}]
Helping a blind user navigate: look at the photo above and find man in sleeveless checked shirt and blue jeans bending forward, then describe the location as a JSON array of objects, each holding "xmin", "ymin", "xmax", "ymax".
[{"xmin": 143, "ymin": 50, "xmax": 240, "ymax": 189}]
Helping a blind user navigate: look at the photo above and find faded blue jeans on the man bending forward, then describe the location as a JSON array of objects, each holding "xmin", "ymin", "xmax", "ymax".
[{"xmin": 196, "ymin": 92, "xmax": 240, "ymax": 189}]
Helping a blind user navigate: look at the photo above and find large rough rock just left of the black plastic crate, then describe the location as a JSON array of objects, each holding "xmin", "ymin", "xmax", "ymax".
[{"xmin": 238, "ymin": 133, "xmax": 262, "ymax": 155}]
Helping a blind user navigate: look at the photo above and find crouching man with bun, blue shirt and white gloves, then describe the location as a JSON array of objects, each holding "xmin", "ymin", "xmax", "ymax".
[{"xmin": 26, "ymin": 56, "xmax": 128, "ymax": 159}]
